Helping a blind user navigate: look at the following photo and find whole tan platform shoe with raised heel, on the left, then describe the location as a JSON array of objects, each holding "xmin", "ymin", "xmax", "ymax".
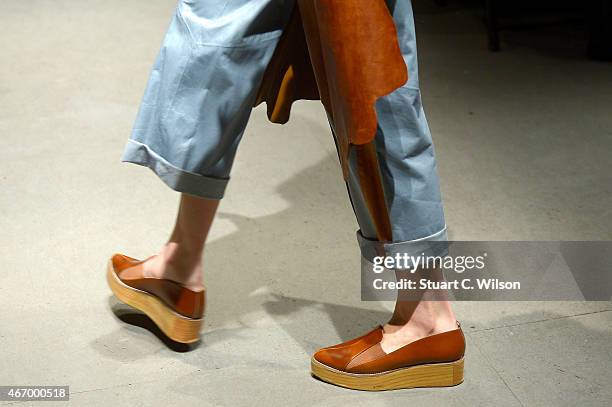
[{"xmin": 106, "ymin": 254, "xmax": 205, "ymax": 343}]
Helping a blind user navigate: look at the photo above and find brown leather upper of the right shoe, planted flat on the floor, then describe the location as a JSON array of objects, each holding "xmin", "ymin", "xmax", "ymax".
[{"xmin": 314, "ymin": 326, "xmax": 465, "ymax": 374}]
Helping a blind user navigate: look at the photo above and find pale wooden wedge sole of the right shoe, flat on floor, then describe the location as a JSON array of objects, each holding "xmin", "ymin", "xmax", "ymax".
[{"xmin": 311, "ymin": 358, "xmax": 463, "ymax": 391}]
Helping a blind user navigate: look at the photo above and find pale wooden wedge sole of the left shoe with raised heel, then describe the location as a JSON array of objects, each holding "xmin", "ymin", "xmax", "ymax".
[{"xmin": 106, "ymin": 261, "xmax": 203, "ymax": 343}]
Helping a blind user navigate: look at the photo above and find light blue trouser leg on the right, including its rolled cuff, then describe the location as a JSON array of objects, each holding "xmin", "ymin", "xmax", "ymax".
[{"xmin": 347, "ymin": 0, "xmax": 447, "ymax": 261}]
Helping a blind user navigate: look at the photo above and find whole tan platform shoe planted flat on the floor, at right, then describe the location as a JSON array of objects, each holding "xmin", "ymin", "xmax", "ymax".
[{"xmin": 311, "ymin": 323, "xmax": 465, "ymax": 391}]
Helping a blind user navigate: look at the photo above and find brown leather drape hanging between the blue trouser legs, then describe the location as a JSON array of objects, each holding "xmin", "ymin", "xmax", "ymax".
[{"xmin": 255, "ymin": 0, "xmax": 408, "ymax": 241}]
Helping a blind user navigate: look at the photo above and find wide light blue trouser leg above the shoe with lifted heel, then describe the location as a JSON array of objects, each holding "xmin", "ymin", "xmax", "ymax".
[{"xmin": 122, "ymin": 0, "xmax": 293, "ymax": 199}]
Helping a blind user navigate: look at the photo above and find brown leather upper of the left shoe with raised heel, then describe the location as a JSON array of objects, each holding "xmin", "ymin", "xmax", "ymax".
[{"xmin": 112, "ymin": 254, "xmax": 205, "ymax": 319}]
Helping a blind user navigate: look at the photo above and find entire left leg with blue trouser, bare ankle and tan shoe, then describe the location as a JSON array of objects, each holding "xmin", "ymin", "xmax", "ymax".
[{"xmin": 107, "ymin": 0, "xmax": 292, "ymax": 343}]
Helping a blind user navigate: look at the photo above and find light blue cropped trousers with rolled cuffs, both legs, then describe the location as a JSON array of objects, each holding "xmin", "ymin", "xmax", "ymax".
[{"xmin": 122, "ymin": 0, "xmax": 447, "ymax": 261}]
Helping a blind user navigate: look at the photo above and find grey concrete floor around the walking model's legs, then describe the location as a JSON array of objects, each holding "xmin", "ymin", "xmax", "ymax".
[{"xmin": 0, "ymin": 0, "xmax": 612, "ymax": 406}]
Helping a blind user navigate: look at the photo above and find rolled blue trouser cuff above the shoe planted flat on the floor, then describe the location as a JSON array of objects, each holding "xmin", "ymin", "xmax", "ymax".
[{"xmin": 357, "ymin": 226, "xmax": 448, "ymax": 263}]
